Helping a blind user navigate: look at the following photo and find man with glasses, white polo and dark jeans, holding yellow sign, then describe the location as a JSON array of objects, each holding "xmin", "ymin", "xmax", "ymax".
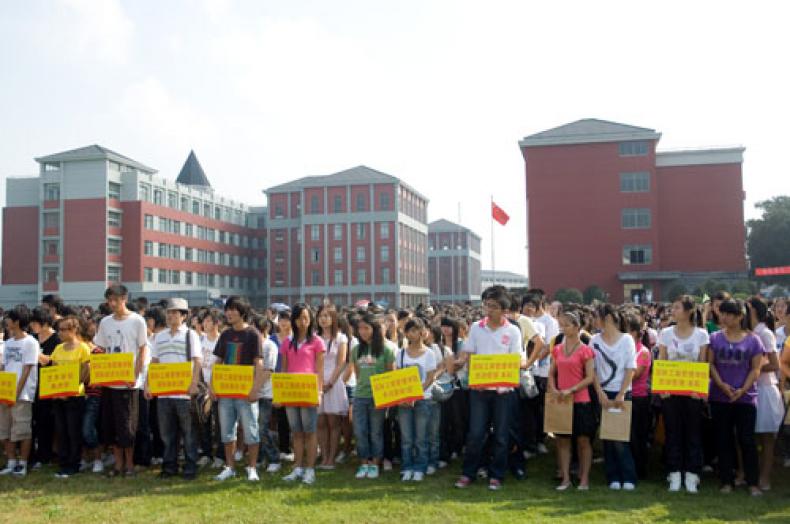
[{"xmin": 453, "ymin": 286, "xmax": 522, "ymax": 490}]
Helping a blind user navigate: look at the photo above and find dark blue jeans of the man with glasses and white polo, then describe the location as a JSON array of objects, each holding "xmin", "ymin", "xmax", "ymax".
[{"xmin": 463, "ymin": 390, "xmax": 516, "ymax": 482}]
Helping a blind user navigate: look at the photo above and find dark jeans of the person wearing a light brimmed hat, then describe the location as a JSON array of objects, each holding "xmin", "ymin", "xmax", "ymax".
[{"xmin": 156, "ymin": 398, "xmax": 197, "ymax": 475}]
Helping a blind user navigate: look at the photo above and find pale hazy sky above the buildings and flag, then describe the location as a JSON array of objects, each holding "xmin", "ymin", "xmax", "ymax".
[{"xmin": 0, "ymin": 0, "xmax": 790, "ymax": 273}]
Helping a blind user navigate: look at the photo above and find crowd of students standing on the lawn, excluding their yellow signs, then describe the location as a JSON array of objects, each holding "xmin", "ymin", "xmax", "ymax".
[{"xmin": 0, "ymin": 285, "xmax": 790, "ymax": 495}]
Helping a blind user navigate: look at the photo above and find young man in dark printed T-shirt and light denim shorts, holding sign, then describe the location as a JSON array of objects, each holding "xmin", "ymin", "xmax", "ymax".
[{"xmin": 211, "ymin": 296, "xmax": 265, "ymax": 482}]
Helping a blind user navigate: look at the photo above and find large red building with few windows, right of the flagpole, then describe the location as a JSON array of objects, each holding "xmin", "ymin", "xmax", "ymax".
[{"xmin": 519, "ymin": 119, "xmax": 747, "ymax": 302}]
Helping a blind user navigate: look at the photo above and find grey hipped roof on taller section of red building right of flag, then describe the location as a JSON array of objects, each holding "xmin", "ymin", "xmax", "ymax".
[{"xmin": 519, "ymin": 118, "xmax": 661, "ymax": 147}]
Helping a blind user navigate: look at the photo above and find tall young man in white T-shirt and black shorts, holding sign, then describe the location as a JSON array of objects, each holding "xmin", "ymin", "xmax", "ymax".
[{"xmin": 93, "ymin": 284, "xmax": 148, "ymax": 477}]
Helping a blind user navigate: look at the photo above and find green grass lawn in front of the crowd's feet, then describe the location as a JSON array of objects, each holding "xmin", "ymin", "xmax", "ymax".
[{"xmin": 0, "ymin": 456, "xmax": 790, "ymax": 524}]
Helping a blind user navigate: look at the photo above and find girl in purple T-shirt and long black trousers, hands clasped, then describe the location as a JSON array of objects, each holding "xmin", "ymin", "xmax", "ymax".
[{"xmin": 708, "ymin": 300, "xmax": 765, "ymax": 496}]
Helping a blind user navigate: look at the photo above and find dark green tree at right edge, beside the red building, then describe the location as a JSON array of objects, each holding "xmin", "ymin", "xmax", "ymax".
[{"xmin": 746, "ymin": 196, "xmax": 790, "ymax": 285}]
